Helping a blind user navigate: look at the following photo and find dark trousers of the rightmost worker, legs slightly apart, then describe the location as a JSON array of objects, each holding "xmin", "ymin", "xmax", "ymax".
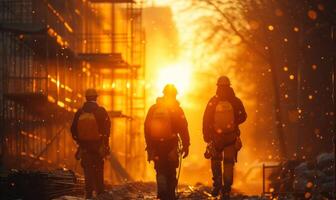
[{"xmin": 211, "ymin": 145, "xmax": 237, "ymax": 194}]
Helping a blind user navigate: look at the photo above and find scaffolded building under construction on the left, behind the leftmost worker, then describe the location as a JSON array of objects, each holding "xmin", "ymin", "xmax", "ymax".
[{"xmin": 0, "ymin": 0, "xmax": 145, "ymax": 181}]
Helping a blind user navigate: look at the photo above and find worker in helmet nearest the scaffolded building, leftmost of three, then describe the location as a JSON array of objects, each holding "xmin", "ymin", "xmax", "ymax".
[{"xmin": 71, "ymin": 89, "xmax": 111, "ymax": 199}]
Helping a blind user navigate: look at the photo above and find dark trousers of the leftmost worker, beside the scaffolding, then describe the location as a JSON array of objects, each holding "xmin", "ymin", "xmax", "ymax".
[{"xmin": 81, "ymin": 151, "xmax": 104, "ymax": 198}]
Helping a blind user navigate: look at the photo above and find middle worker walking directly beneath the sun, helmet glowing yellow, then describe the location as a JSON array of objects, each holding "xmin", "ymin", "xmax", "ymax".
[{"xmin": 144, "ymin": 84, "xmax": 190, "ymax": 200}]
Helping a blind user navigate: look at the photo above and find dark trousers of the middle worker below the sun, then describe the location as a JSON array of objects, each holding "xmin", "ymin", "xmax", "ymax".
[{"xmin": 153, "ymin": 140, "xmax": 179, "ymax": 200}]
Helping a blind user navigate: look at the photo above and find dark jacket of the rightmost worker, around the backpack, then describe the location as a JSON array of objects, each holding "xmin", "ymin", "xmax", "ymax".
[{"xmin": 203, "ymin": 87, "xmax": 247, "ymax": 143}]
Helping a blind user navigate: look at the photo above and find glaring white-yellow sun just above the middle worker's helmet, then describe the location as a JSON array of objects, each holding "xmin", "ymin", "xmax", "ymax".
[{"xmin": 156, "ymin": 62, "xmax": 192, "ymax": 96}]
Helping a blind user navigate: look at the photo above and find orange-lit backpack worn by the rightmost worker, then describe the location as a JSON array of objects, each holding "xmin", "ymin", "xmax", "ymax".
[{"xmin": 214, "ymin": 101, "xmax": 235, "ymax": 134}]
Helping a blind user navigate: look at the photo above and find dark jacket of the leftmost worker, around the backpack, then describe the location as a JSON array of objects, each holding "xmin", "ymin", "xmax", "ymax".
[{"xmin": 71, "ymin": 101, "xmax": 111, "ymax": 151}]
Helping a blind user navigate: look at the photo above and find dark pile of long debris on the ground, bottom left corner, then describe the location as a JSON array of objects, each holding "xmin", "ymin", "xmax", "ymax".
[{"xmin": 0, "ymin": 169, "xmax": 84, "ymax": 199}]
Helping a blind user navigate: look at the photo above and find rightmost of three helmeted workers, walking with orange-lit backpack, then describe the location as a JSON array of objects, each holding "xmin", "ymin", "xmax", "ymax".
[{"xmin": 203, "ymin": 76, "xmax": 247, "ymax": 199}]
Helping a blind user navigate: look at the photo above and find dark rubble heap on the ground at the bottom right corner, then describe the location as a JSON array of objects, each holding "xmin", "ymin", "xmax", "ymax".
[{"xmin": 268, "ymin": 153, "xmax": 335, "ymax": 199}]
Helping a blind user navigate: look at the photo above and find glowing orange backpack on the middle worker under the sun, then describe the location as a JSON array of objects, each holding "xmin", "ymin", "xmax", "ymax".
[{"xmin": 149, "ymin": 105, "xmax": 173, "ymax": 141}]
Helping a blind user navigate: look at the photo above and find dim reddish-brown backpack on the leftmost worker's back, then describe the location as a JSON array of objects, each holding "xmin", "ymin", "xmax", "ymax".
[{"xmin": 77, "ymin": 112, "xmax": 101, "ymax": 141}]
